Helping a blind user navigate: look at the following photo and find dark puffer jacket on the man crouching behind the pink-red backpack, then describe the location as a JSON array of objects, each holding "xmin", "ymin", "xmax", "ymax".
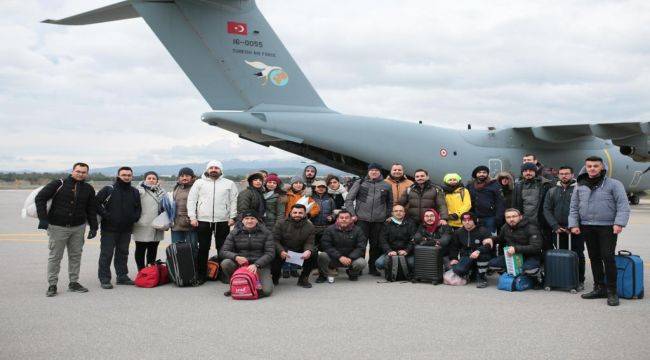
[{"xmin": 220, "ymin": 223, "xmax": 275, "ymax": 267}]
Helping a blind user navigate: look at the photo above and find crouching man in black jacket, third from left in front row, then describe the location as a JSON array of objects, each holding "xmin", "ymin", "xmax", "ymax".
[{"xmin": 316, "ymin": 210, "xmax": 366, "ymax": 283}]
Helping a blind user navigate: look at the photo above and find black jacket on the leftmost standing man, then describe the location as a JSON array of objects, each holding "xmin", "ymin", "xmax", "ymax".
[{"xmin": 35, "ymin": 176, "xmax": 97, "ymax": 230}]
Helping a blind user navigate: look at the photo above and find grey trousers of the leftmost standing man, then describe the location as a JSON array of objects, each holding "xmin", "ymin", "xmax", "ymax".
[{"xmin": 47, "ymin": 224, "xmax": 86, "ymax": 285}]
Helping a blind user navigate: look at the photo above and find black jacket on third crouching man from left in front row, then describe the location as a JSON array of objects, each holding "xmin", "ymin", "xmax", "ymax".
[{"xmin": 320, "ymin": 224, "xmax": 366, "ymax": 260}]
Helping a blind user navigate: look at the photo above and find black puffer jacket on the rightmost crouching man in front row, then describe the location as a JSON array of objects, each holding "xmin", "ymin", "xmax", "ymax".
[{"xmin": 492, "ymin": 219, "xmax": 542, "ymax": 256}]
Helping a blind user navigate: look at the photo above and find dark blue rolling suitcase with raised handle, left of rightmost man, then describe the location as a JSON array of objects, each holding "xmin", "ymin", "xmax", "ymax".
[{"xmin": 544, "ymin": 234, "xmax": 580, "ymax": 294}]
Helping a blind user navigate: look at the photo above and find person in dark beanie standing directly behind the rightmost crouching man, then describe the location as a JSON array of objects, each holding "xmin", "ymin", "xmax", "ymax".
[{"xmin": 512, "ymin": 159, "xmax": 553, "ymax": 250}]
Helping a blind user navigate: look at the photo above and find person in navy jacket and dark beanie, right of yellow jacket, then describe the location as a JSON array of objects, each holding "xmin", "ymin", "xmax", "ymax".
[{"xmin": 467, "ymin": 165, "xmax": 505, "ymax": 234}]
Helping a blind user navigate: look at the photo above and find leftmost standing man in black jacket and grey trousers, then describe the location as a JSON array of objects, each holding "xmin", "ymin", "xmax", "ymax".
[{"xmin": 34, "ymin": 163, "xmax": 97, "ymax": 297}]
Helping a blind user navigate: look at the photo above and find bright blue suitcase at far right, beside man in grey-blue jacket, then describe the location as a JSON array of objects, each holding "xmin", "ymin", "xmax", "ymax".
[{"xmin": 614, "ymin": 250, "xmax": 643, "ymax": 299}]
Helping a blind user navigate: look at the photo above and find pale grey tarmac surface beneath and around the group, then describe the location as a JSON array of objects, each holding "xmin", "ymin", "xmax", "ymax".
[{"xmin": 0, "ymin": 190, "xmax": 650, "ymax": 360}]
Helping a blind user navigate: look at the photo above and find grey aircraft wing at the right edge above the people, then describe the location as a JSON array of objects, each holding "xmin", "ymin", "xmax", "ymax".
[{"xmin": 513, "ymin": 121, "xmax": 650, "ymax": 162}]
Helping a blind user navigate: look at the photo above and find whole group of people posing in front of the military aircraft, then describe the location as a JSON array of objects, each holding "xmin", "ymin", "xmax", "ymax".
[{"xmin": 36, "ymin": 154, "xmax": 630, "ymax": 305}]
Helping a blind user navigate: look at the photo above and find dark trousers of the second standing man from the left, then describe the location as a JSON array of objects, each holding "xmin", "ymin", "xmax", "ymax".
[{"xmin": 97, "ymin": 231, "xmax": 131, "ymax": 284}]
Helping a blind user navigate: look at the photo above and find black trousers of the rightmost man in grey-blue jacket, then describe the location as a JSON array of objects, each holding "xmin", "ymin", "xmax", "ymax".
[{"xmin": 580, "ymin": 225, "xmax": 618, "ymax": 293}]
